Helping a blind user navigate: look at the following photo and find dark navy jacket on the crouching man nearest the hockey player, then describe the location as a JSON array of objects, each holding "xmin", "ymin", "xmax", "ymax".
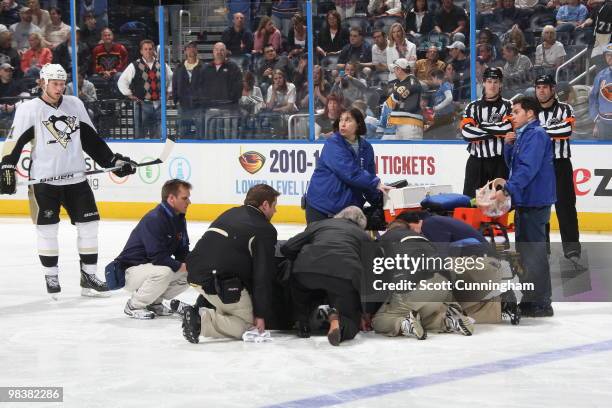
[{"xmin": 117, "ymin": 203, "xmax": 189, "ymax": 272}]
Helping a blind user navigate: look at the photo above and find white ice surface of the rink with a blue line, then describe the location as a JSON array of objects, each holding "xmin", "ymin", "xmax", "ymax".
[{"xmin": 0, "ymin": 218, "xmax": 612, "ymax": 408}]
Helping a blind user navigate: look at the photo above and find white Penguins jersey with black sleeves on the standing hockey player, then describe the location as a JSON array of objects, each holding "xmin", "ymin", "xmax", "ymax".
[{"xmin": 2, "ymin": 96, "xmax": 113, "ymax": 185}]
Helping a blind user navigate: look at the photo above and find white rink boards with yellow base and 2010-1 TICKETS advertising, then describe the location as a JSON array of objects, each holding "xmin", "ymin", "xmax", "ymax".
[{"xmin": 0, "ymin": 142, "xmax": 612, "ymax": 231}]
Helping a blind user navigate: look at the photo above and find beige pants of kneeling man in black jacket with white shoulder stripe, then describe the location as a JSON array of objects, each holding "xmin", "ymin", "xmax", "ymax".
[{"xmin": 194, "ymin": 286, "xmax": 254, "ymax": 340}]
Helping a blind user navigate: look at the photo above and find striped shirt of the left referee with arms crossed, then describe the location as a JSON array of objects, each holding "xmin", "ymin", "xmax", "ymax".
[{"xmin": 461, "ymin": 97, "xmax": 512, "ymax": 158}]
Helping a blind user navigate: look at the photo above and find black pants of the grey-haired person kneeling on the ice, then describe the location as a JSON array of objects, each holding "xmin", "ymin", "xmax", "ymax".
[{"xmin": 291, "ymin": 273, "xmax": 361, "ymax": 341}]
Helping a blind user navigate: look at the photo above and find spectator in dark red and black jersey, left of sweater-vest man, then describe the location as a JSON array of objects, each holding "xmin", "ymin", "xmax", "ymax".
[{"xmin": 91, "ymin": 28, "xmax": 128, "ymax": 80}]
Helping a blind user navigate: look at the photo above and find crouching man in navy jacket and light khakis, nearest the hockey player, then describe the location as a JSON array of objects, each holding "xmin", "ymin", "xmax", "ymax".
[{"xmin": 117, "ymin": 179, "xmax": 191, "ymax": 319}]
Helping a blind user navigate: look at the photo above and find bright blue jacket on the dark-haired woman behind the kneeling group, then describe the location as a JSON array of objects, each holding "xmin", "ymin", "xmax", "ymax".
[{"xmin": 306, "ymin": 133, "xmax": 381, "ymax": 215}]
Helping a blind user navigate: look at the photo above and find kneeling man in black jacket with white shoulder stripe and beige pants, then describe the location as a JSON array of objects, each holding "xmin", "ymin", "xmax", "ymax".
[{"xmin": 183, "ymin": 184, "xmax": 280, "ymax": 343}]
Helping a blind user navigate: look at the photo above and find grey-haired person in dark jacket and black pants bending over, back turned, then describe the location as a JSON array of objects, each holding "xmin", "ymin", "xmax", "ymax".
[{"xmin": 280, "ymin": 206, "xmax": 370, "ymax": 346}]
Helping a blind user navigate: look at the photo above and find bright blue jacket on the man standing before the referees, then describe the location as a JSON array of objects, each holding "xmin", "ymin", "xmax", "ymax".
[{"xmin": 504, "ymin": 120, "xmax": 557, "ymax": 207}]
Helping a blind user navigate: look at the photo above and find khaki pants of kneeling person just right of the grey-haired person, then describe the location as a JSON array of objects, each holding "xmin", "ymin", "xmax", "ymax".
[{"xmin": 372, "ymin": 274, "xmax": 452, "ymax": 337}]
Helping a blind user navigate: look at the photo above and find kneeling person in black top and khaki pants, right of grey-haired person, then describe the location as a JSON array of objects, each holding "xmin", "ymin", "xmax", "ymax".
[{"xmin": 372, "ymin": 217, "xmax": 474, "ymax": 340}]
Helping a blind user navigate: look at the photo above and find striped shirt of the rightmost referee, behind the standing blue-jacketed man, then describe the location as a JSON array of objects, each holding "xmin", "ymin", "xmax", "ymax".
[{"xmin": 538, "ymin": 100, "xmax": 576, "ymax": 159}]
